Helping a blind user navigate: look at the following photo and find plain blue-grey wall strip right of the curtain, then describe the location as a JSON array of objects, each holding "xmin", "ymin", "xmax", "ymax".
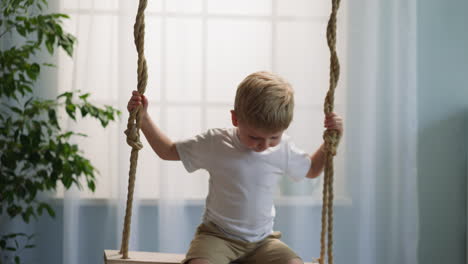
[{"xmin": 418, "ymin": 0, "xmax": 468, "ymax": 263}]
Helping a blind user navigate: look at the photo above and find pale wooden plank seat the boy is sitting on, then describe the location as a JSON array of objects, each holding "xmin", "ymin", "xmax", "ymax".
[{"xmin": 104, "ymin": 249, "xmax": 317, "ymax": 264}]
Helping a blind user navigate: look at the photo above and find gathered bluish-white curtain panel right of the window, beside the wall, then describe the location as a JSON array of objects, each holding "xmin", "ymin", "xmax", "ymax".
[{"xmin": 346, "ymin": 0, "xmax": 419, "ymax": 263}]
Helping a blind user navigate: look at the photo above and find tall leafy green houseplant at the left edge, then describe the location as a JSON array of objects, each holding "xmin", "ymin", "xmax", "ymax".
[{"xmin": 0, "ymin": 0, "xmax": 120, "ymax": 264}]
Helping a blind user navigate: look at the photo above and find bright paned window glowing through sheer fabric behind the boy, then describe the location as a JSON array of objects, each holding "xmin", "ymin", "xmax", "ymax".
[{"xmin": 59, "ymin": 0, "xmax": 346, "ymax": 202}]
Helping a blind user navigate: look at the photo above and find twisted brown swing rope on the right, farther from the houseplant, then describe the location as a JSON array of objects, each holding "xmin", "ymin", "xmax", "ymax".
[{"xmin": 318, "ymin": 0, "xmax": 340, "ymax": 264}]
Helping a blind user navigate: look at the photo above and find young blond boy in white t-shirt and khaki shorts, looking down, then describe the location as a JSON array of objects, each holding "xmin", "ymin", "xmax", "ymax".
[{"xmin": 127, "ymin": 72, "xmax": 343, "ymax": 264}]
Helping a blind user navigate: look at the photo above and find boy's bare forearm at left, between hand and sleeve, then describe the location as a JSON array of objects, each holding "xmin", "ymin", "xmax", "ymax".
[{"xmin": 141, "ymin": 114, "xmax": 180, "ymax": 160}]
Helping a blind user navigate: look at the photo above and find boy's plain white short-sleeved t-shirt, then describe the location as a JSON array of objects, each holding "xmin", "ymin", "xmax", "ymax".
[{"xmin": 176, "ymin": 128, "xmax": 311, "ymax": 242}]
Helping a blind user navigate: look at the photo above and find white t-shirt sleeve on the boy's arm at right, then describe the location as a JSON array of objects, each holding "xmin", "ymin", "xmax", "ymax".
[{"xmin": 286, "ymin": 138, "xmax": 312, "ymax": 181}]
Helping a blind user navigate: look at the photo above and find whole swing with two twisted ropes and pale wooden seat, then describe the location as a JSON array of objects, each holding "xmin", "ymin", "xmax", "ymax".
[{"xmin": 104, "ymin": 0, "xmax": 340, "ymax": 264}]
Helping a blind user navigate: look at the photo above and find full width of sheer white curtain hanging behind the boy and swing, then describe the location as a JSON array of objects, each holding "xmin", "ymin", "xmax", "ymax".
[{"xmin": 38, "ymin": 0, "xmax": 418, "ymax": 264}]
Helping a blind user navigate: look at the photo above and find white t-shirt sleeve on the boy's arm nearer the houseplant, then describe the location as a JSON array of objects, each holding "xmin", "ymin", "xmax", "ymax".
[{"xmin": 175, "ymin": 131, "xmax": 213, "ymax": 172}]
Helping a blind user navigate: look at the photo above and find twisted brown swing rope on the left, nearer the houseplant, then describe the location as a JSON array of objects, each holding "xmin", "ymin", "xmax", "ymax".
[{"xmin": 120, "ymin": 0, "xmax": 148, "ymax": 259}]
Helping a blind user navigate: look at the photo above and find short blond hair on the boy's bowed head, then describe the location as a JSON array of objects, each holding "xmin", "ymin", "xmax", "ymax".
[{"xmin": 234, "ymin": 71, "xmax": 294, "ymax": 132}]
